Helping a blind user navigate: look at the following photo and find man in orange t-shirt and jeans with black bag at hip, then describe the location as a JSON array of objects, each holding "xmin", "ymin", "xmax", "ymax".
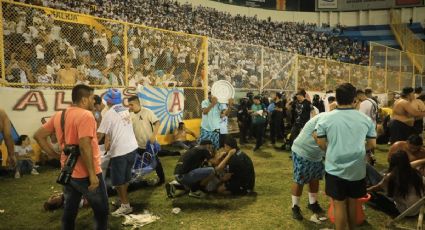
[{"xmin": 34, "ymin": 85, "xmax": 109, "ymax": 229}]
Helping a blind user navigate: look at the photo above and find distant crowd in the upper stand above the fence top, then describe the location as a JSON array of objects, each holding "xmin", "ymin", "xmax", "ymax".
[{"xmin": 16, "ymin": 0, "xmax": 368, "ymax": 65}]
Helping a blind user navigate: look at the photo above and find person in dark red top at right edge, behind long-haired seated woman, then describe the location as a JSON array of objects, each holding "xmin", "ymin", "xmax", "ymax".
[{"xmin": 388, "ymin": 134, "xmax": 425, "ymax": 162}]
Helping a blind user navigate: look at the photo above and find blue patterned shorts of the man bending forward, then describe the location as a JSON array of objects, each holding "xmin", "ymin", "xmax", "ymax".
[{"xmin": 292, "ymin": 152, "xmax": 325, "ymax": 185}]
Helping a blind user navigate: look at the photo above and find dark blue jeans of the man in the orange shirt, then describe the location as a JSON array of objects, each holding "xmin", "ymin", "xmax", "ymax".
[{"xmin": 62, "ymin": 173, "xmax": 109, "ymax": 230}]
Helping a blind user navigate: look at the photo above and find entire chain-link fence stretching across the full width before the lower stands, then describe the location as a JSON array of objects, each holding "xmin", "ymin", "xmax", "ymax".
[{"xmin": 0, "ymin": 1, "xmax": 425, "ymax": 99}]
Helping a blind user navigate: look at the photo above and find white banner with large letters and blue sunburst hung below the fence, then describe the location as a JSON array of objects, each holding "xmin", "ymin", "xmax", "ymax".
[{"xmin": 0, "ymin": 87, "xmax": 185, "ymax": 142}]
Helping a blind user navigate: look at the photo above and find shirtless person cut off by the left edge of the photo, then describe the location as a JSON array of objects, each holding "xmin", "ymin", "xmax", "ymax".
[{"xmin": 0, "ymin": 109, "xmax": 16, "ymax": 167}]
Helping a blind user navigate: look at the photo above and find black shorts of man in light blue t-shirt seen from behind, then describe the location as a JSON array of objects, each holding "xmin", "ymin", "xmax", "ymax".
[{"xmin": 325, "ymin": 173, "xmax": 366, "ymax": 201}]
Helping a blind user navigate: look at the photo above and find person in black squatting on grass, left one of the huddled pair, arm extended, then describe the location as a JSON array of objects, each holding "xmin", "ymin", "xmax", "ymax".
[{"xmin": 165, "ymin": 140, "xmax": 236, "ymax": 198}]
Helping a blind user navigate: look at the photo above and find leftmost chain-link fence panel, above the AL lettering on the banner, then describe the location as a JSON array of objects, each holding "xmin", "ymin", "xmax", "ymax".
[{"xmin": 2, "ymin": 2, "xmax": 126, "ymax": 88}]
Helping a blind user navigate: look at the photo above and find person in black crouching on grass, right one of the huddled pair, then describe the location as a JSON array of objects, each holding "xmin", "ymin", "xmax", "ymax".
[{"xmin": 217, "ymin": 137, "xmax": 255, "ymax": 195}]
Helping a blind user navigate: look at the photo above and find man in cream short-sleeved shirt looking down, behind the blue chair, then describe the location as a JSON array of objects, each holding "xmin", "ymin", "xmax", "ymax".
[{"xmin": 128, "ymin": 96, "xmax": 165, "ymax": 185}]
